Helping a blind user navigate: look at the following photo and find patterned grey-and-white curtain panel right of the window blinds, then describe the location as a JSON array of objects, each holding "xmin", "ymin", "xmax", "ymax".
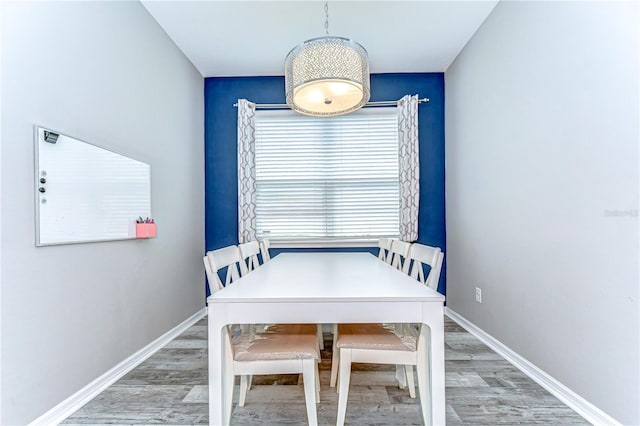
[{"xmin": 398, "ymin": 95, "xmax": 420, "ymax": 241}]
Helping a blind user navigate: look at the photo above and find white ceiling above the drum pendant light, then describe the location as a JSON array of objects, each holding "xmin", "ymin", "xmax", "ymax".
[{"xmin": 142, "ymin": 0, "xmax": 498, "ymax": 77}]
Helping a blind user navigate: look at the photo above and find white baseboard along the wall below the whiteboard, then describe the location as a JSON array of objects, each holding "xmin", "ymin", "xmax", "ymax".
[{"xmin": 30, "ymin": 308, "xmax": 207, "ymax": 426}]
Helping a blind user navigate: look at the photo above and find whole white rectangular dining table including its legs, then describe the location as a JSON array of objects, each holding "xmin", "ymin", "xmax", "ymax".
[{"xmin": 207, "ymin": 252, "xmax": 446, "ymax": 425}]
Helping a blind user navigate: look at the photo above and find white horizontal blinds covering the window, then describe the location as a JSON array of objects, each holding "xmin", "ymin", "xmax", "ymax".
[{"xmin": 255, "ymin": 107, "xmax": 400, "ymax": 242}]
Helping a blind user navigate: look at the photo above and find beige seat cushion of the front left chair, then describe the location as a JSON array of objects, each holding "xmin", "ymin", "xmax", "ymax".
[{"xmin": 232, "ymin": 324, "xmax": 320, "ymax": 361}]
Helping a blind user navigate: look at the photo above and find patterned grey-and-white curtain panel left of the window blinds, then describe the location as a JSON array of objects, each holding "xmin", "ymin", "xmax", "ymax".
[{"xmin": 238, "ymin": 99, "xmax": 257, "ymax": 244}]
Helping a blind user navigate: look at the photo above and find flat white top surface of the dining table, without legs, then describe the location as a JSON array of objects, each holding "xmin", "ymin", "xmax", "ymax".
[{"xmin": 208, "ymin": 252, "xmax": 445, "ymax": 303}]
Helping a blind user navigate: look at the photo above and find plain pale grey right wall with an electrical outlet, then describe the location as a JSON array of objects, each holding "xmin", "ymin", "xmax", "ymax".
[{"xmin": 445, "ymin": 1, "xmax": 640, "ymax": 424}]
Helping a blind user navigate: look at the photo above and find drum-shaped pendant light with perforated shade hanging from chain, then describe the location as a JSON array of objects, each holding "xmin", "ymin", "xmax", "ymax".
[{"xmin": 284, "ymin": 2, "xmax": 370, "ymax": 117}]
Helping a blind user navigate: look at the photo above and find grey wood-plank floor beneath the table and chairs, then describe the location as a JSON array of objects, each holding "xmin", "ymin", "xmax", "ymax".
[{"xmin": 63, "ymin": 318, "xmax": 588, "ymax": 425}]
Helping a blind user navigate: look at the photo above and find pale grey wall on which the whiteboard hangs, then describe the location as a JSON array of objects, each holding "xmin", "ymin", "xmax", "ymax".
[{"xmin": 0, "ymin": 2, "xmax": 204, "ymax": 424}]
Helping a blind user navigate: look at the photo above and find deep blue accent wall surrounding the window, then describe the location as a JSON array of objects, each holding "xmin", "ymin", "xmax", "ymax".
[{"xmin": 204, "ymin": 73, "xmax": 446, "ymax": 294}]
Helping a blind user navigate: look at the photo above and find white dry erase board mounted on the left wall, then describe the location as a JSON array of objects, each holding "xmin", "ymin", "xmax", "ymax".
[{"xmin": 34, "ymin": 126, "xmax": 151, "ymax": 246}]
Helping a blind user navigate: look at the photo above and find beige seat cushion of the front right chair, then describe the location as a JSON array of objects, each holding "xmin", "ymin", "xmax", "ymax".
[{"xmin": 336, "ymin": 324, "xmax": 417, "ymax": 351}]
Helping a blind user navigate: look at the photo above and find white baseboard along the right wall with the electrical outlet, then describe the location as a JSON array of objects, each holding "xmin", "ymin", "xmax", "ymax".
[{"xmin": 445, "ymin": 308, "xmax": 621, "ymax": 425}]
